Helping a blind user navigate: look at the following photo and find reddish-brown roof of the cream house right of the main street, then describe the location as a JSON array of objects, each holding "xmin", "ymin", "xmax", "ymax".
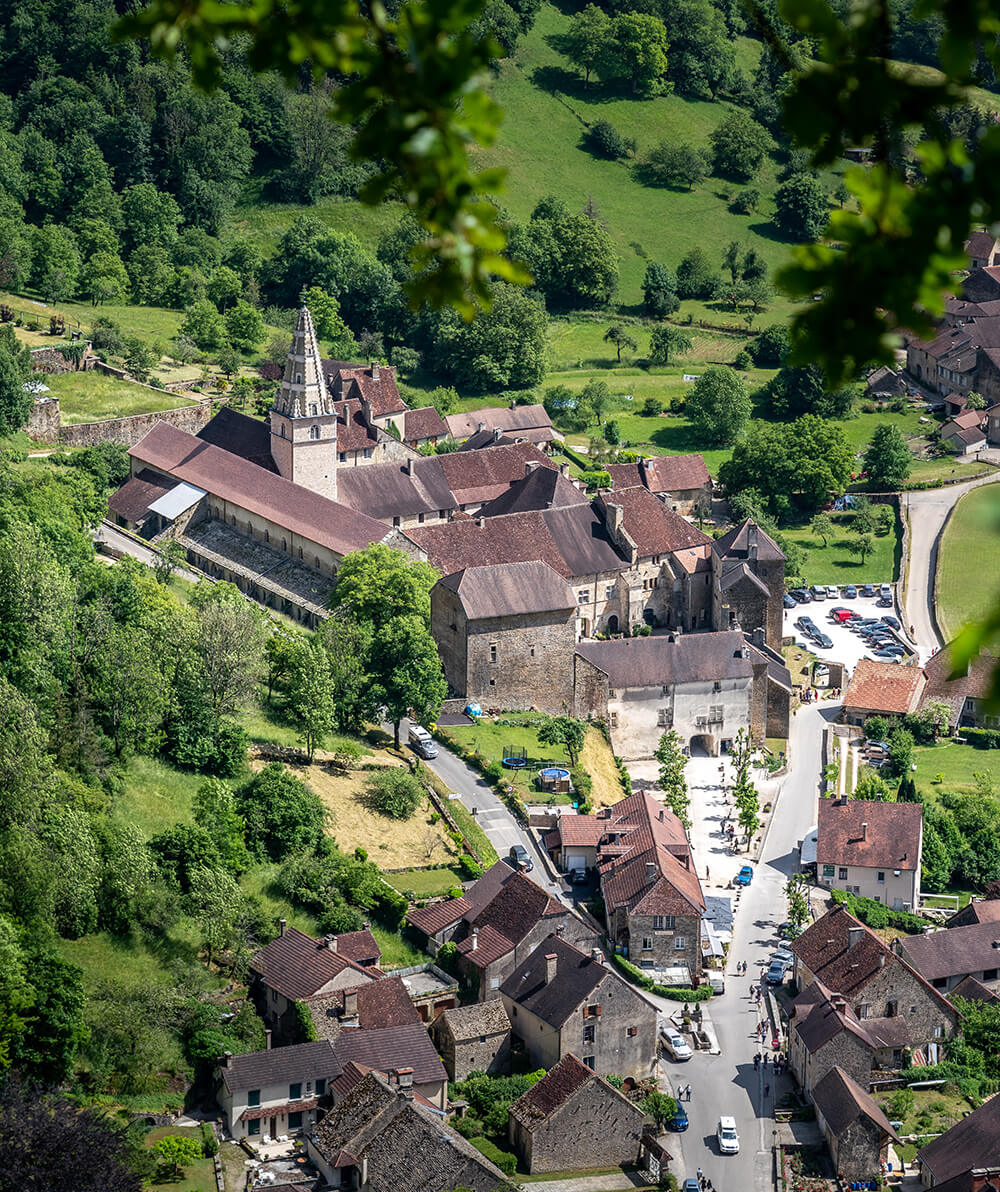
[{"xmin": 816, "ymin": 799, "xmax": 924, "ymax": 870}]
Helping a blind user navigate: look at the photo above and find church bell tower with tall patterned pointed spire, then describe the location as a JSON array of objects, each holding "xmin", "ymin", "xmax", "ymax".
[{"xmin": 271, "ymin": 306, "xmax": 337, "ymax": 501}]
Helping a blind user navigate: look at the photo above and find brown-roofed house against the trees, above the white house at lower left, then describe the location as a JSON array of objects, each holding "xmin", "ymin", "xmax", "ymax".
[{"xmin": 249, "ymin": 919, "xmax": 383, "ymax": 1038}]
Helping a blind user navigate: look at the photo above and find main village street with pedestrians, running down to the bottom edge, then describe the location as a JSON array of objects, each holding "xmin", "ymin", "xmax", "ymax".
[{"xmin": 660, "ymin": 703, "xmax": 840, "ymax": 1192}]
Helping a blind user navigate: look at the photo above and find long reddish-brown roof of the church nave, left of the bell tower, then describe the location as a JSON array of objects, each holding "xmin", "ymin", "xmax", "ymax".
[{"xmin": 129, "ymin": 422, "xmax": 386, "ymax": 555}]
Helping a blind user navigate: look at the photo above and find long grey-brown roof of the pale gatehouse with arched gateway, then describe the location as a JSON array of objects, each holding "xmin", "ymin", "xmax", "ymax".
[{"xmin": 577, "ymin": 631, "xmax": 753, "ymax": 689}]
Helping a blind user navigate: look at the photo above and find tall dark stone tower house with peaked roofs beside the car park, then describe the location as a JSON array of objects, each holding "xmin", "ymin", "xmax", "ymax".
[{"xmin": 712, "ymin": 517, "xmax": 784, "ymax": 653}]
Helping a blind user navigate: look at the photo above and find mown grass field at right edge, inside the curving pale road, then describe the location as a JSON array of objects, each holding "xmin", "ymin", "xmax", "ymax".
[{"xmin": 937, "ymin": 484, "xmax": 1000, "ymax": 641}]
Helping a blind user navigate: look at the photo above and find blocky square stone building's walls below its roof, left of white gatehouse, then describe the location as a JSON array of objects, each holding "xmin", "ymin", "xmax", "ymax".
[{"xmin": 430, "ymin": 584, "xmax": 576, "ymax": 715}]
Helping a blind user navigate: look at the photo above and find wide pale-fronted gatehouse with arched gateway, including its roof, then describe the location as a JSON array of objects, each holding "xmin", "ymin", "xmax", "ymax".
[{"xmin": 573, "ymin": 631, "xmax": 791, "ymax": 760}]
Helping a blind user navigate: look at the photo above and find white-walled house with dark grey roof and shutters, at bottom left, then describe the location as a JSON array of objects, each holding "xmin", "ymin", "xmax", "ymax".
[{"xmin": 216, "ymin": 1035, "xmax": 341, "ymax": 1142}]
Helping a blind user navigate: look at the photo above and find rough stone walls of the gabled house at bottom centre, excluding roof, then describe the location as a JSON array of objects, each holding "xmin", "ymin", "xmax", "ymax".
[{"xmin": 510, "ymin": 1080, "xmax": 642, "ymax": 1174}]
